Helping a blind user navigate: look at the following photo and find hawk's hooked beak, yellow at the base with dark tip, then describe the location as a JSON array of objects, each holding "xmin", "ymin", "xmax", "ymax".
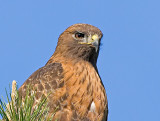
[{"xmin": 80, "ymin": 34, "xmax": 100, "ymax": 52}]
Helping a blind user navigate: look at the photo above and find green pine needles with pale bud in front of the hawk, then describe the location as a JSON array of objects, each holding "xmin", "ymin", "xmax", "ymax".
[{"xmin": 0, "ymin": 81, "xmax": 54, "ymax": 121}]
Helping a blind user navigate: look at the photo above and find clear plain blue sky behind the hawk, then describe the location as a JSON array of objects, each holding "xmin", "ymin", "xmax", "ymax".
[{"xmin": 0, "ymin": 0, "xmax": 160, "ymax": 121}]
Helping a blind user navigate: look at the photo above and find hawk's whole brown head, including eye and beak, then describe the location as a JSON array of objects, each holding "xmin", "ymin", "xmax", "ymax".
[{"xmin": 52, "ymin": 24, "xmax": 102, "ymax": 63}]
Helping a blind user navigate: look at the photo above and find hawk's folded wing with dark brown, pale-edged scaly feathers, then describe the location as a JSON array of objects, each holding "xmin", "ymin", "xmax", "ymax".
[{"xmin": 19, "ymin": 63, "xmax": 64, "ymax": 107}]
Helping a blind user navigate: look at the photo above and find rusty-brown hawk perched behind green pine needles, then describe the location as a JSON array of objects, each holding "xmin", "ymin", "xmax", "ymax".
[{"xmin": 19, "ymin": 24, "xmax": 108, "ymax": 121}]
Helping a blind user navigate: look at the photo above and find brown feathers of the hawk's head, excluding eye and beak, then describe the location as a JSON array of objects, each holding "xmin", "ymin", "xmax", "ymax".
[{"xmin": 47, "ymin": 24, "xmax": 103, "ymax": 65}]
